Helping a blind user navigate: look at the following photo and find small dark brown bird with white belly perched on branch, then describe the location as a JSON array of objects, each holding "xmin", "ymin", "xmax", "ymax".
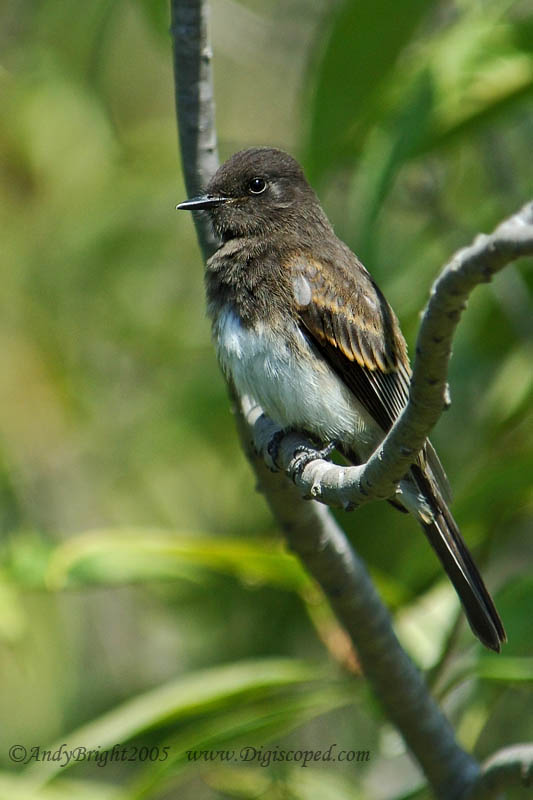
[{"xmin": 178, "ymin": 147, "xmax": 506, "ymax": 651}]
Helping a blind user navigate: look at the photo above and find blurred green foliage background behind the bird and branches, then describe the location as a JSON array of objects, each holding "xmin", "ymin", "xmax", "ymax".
[{"xmin": 0, "ymin": 0, "xmax": 533, "ymax": 800}]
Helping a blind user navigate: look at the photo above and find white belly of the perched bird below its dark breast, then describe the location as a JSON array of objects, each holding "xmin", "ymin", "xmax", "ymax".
[{"xmin": 214, "ymin": 311, "xmax": 383, "ymax": 456}]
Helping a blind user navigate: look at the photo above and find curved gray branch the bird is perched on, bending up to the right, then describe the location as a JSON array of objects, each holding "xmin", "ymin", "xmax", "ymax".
[{"xmin": 248, "ymin": 202, "xmax": 533, "ymax": 509}]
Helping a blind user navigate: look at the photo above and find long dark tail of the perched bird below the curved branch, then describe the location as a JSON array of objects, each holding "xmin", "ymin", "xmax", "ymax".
[{"xmin": 411, "ymin": 466, "xmax": 507, "ymax": 653}]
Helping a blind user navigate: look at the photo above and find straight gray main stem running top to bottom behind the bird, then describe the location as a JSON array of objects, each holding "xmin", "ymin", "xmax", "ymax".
[{"xmin": 171, "ymin": 0, "xmax": 528, "ymax": 800}]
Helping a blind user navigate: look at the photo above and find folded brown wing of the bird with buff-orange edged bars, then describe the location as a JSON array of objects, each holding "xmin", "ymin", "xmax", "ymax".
[{"xmin": 291, "ymin": 253, "xmax": 411, "ymax": 432}]
